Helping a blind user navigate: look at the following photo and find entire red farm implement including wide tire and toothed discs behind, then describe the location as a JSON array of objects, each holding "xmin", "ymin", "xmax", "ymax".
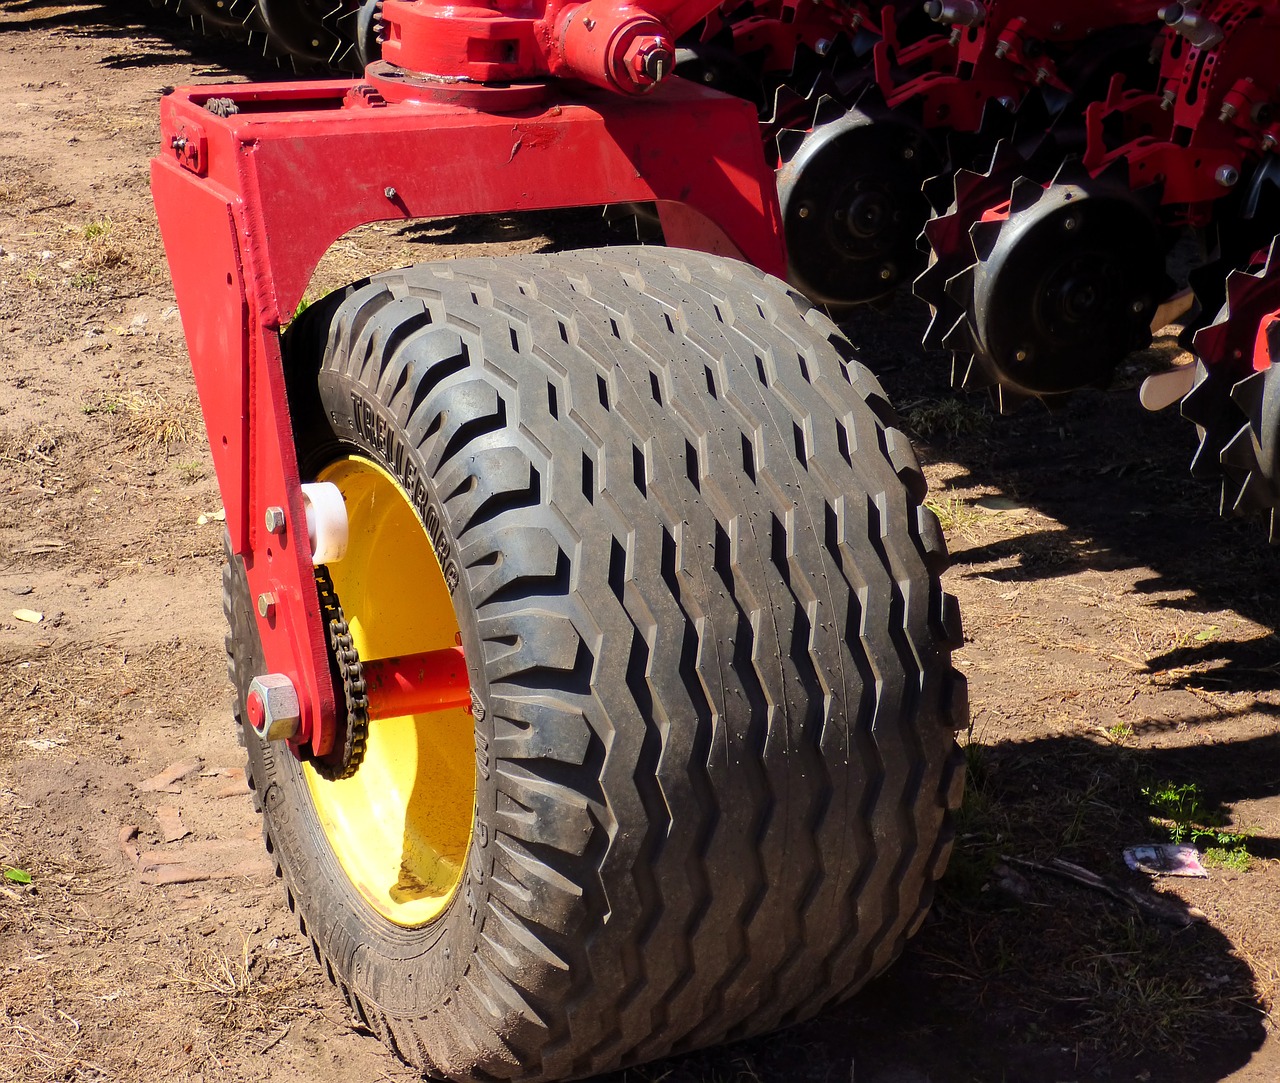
[{"xmin": 152, "ymin": 0, "xmax": 1280, "ymax": 1080}]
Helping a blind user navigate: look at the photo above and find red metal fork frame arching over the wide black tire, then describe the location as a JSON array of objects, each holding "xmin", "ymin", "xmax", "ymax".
[{"xmin": 151, "ymin": 72, "xmax": 786, "ymax": 755}]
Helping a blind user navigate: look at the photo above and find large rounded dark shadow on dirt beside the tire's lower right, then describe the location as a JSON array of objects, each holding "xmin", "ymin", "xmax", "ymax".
[{"xmin": 595, "ymin": 722, "xmax": 1280, "ymax": 1083}]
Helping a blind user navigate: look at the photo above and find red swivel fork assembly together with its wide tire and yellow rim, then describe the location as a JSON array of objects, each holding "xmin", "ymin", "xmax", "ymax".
[{"xmin": 152, "ymin": 0, "xmax": 966, "ymax": 1080}]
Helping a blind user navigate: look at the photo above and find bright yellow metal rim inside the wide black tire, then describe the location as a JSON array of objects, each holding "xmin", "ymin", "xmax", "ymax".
[{"xmin": 303, "ymin": 456, "xmax": 476, "ymax": 927}]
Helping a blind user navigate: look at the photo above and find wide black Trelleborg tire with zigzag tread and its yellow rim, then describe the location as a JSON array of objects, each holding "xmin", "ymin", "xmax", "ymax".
[{"xmin": 225, "ymin": 248, "xmax": 966, "ymax": 1080}]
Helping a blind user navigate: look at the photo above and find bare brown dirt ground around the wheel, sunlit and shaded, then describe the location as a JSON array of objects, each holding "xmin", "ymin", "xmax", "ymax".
[{"xmin": 0, "ymin": 0, "xmax": 1280, "ymax": 1083}]
